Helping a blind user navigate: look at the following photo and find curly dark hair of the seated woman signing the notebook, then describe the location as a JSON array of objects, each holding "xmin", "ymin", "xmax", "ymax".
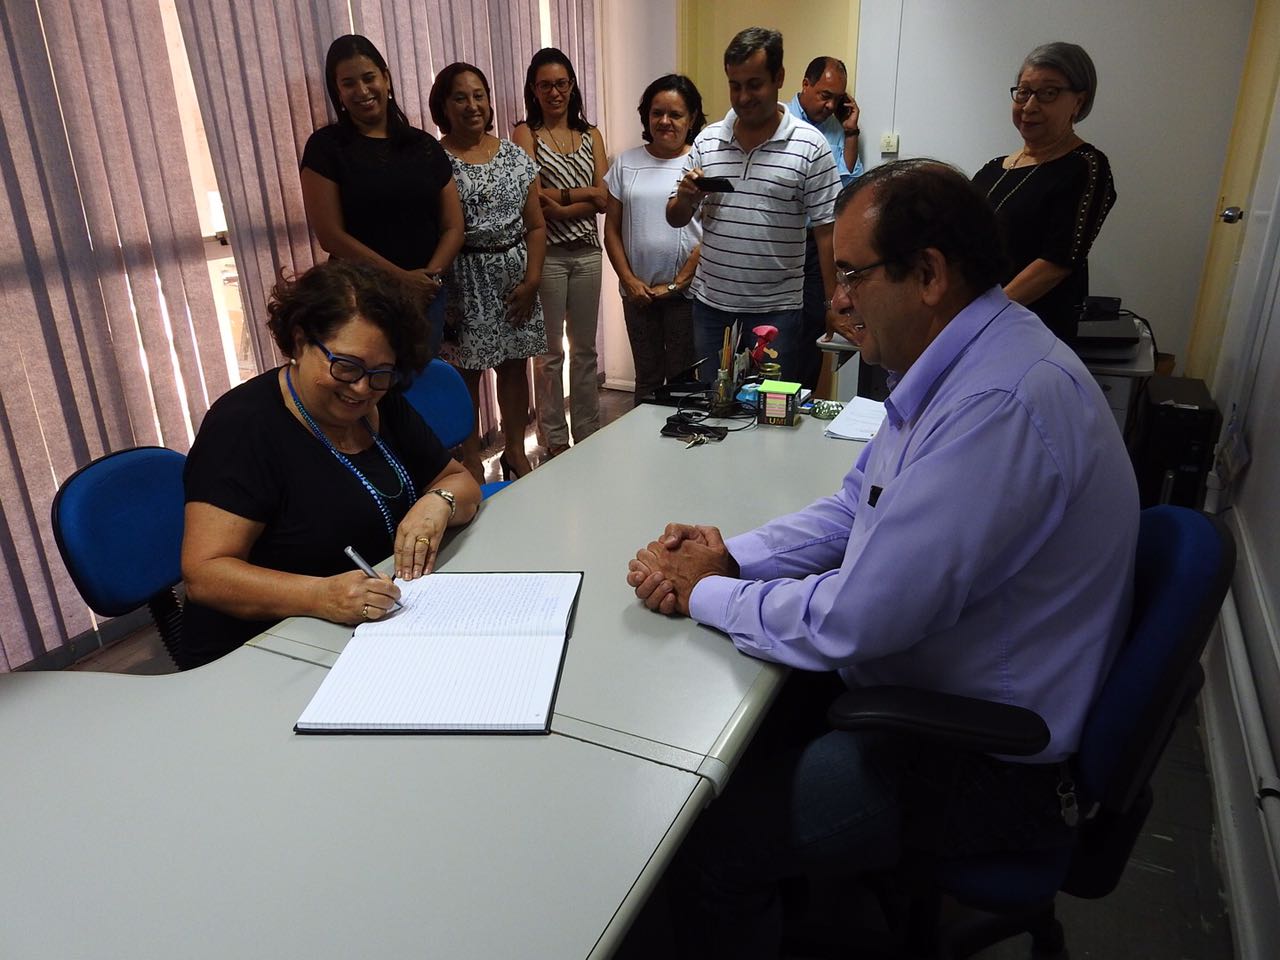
[{"xmin": 266, "ymin": 260, "xmax": 431, "ymax": 388}]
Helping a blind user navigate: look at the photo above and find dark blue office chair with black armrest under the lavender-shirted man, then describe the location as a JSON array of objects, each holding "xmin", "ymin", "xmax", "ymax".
[{"xmin": 828, "ymin": 506, "xmax": 1235, "ymax": 957}]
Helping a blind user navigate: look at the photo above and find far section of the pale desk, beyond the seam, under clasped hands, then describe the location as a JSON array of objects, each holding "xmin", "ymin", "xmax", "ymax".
[{"xmin": 256, "ymin": 406, "xmax": 861, "ymax": 790}]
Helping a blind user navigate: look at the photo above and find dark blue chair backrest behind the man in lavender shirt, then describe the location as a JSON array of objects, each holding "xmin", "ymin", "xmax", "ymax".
[{"xmin": 1076, "ymin": 504, "xmax": 1235, "ymax": 814}]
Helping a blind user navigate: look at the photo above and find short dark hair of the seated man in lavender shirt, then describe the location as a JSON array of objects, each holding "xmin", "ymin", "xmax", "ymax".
[{"xmin": 836, "ymin": 157, "xmax": 1005, "ymax": 296}]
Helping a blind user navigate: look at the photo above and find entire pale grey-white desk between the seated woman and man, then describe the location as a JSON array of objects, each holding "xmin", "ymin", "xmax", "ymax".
[{"xmin": 0, "ymin": 407, "xmax": 860, "ymax": 960}]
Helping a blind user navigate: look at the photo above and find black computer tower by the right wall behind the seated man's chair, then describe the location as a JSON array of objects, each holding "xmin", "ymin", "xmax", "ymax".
[{"xmin": 1130, "ymin": 376, "xmax": 1222, "ymax": 509}]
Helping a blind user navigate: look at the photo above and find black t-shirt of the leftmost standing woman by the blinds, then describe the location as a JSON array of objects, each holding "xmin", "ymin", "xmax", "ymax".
[{"xmin": 301, "ymin": 123, "xmax": 453, "ymax": 270}]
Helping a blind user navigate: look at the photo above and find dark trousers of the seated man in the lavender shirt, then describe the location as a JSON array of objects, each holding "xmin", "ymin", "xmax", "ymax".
[{"xmin": 669, "ymin": 672, "xmax": 1071, "ymax": 959}]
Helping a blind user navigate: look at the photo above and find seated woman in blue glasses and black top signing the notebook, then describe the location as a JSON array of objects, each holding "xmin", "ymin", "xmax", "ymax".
[{"xmin": 178, "ymin": 260, "xmax": 480, "ymax": 668}]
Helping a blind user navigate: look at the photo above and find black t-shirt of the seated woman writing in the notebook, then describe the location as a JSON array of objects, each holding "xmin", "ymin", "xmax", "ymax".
[{"xmin": 179, "ymin": 370, "xmax": 449, "ymax": 667}]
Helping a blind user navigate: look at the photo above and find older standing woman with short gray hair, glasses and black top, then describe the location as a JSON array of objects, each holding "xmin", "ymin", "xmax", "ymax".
[{"xmin": 973, "ymin": 42, "xmax": 1116, "ymax": 339}]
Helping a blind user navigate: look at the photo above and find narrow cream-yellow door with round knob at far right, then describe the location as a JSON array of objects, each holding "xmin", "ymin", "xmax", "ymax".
[{"xmin": 1185, "ymin": 0, "xmax": 1280, "ymax": 381}]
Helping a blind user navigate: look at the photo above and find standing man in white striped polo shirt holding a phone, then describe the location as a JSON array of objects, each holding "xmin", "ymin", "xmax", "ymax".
[{"xmin": 667, "ymin": 27, "xmax": 840, "ymax": 383}]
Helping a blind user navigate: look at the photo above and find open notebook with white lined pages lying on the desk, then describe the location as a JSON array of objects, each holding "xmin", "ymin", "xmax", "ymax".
[{"xmin": 293, "ymin": 572, "xmax": 582, "ymax": 733}]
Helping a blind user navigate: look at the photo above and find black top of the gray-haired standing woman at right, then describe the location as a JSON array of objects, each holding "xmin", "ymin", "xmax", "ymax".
[{"xmin": 973, "ymin": 143, "xmax": 1116, "ymax": 339}]
